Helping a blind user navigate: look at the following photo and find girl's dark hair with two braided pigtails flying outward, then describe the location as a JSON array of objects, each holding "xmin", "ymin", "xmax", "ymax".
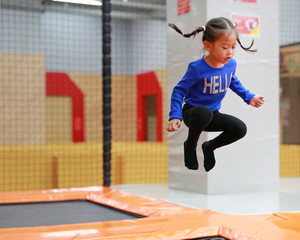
[{"xmin": 169, "ymin": 17, "xmax": 257, "ymax": 53}]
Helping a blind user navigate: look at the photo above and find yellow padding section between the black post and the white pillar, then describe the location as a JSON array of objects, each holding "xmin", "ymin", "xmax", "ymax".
[{"xmin": 112, "ymin": 142, "xmax": 168, "ymax": 184}]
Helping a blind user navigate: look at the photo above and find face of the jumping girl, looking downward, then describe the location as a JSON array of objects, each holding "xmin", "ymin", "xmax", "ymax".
[{"xmin": 204, "ymin": 31, "xmax": 237, "ymax": 67}]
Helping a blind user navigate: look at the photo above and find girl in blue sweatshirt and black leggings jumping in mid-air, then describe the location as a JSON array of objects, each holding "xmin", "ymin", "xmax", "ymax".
[{"xmin": 167, "ymin": 17, "xmax": 264, "ymax": 172}]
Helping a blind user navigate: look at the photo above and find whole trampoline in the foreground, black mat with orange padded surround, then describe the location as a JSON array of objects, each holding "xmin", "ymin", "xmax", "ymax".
[{"xmin": 0, "ymin": 187, "xmax": 300, "ymax": 240}]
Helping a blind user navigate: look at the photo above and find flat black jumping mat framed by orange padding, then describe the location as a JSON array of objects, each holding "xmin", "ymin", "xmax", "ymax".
[{"xmin": 0, "ymin": 200, "xmax": 142, "ymax": 228}]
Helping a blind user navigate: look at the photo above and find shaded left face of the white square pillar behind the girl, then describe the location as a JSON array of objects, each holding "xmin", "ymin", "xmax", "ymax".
[{"xmin": 167, "ymin": 0, "xmax": 207, "ymax": 192}]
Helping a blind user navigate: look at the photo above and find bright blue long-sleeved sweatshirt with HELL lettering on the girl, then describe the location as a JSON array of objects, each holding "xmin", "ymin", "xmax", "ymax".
[{"xmin": 169, "ymin": 57, "xmax": 254, "ymax": 120}]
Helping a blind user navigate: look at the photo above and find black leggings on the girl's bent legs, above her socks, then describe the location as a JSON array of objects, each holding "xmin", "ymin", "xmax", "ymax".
[{"xmin": 182, "ymin": 104, "xmax": 247, "ymax": 150}]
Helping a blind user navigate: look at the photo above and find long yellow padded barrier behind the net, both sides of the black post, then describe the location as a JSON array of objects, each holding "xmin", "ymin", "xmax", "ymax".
[{"xmin": 0, "ymin": 142, "xmax": 167, "ymax": 191}]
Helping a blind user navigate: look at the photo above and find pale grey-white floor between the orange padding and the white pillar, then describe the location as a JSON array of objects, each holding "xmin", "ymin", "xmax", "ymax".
[{"xmin": 112, "ymin": 178, "xmax": 300, "ymax": 215}]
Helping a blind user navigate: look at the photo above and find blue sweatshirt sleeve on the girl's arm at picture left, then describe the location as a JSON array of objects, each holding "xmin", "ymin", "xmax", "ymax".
[{"xmin": 169, "ymin": 64, "xmax": 197, "ymax": 121}]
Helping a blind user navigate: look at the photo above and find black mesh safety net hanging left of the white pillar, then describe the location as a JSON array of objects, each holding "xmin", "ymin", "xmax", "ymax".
[{"xmin": 0, "ymin": 0, "xmax": 167, "ymax": 191}]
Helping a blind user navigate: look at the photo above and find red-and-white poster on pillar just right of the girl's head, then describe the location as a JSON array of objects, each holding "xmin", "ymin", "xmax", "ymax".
[{"xmin": 231, "ymin": 15, "xmax": 259, "ymax": 36}]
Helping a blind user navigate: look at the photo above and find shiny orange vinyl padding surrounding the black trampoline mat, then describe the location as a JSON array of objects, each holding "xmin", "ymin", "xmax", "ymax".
[{"xmin": 0, "ymin": 187, "xmax": 300, "ymax": 240}]
